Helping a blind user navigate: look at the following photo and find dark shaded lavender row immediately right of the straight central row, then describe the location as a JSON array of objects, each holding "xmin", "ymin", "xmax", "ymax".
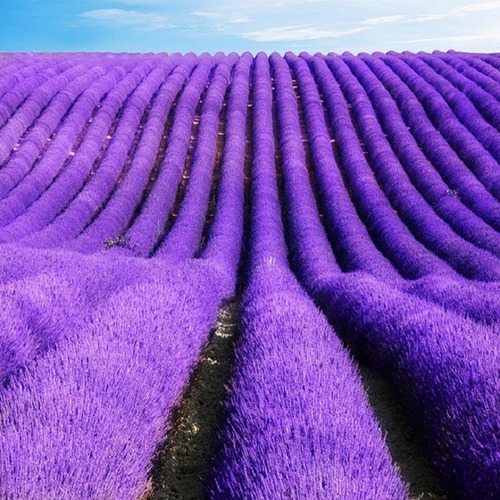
[{"xmin": 277, "ymin": 50, "xmax": 500, "ymax": 498}]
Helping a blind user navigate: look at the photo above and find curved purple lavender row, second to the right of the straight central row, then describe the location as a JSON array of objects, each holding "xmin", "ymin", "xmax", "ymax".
[{"xmin": 285, "ymin": 52, "xmax": 500, "ymax": 325}]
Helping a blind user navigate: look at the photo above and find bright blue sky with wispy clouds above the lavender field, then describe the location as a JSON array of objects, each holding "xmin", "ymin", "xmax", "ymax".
[{"xmin": 0, "ymin": 0, "xmax": 500, "ymax": 53}]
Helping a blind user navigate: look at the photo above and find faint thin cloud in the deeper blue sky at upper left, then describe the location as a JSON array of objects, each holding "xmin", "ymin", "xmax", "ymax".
[{"xmin": 80, "ymin": 9, "xmax": 172, "ymax": 30}]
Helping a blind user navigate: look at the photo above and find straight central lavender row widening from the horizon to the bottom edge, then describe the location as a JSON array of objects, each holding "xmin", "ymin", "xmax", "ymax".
[{"xmin": 207, "ymin": 54, "xmax": 407, "ymax": 498}]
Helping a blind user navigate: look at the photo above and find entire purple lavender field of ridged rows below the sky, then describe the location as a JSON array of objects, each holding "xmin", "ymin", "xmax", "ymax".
[{"xmin": 0, "ymin": 52, "xmax": 500, "ymax": 500}]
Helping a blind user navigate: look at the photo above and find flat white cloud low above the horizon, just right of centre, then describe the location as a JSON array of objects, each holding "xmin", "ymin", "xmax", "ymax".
[{"xmin": 242, "ymin": 24, "xmax": 368, "ymax": 42}]
